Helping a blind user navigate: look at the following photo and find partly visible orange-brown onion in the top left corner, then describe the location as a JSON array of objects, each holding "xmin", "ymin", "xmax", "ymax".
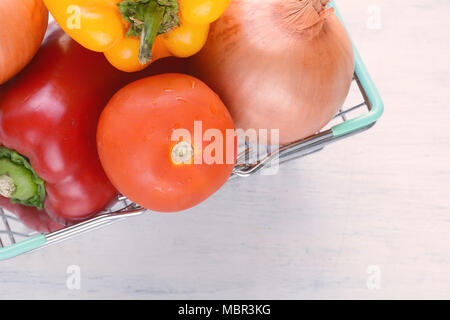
[{"xmin": 0, "ymin": 0, "xmax": 48, "ymax": 85}]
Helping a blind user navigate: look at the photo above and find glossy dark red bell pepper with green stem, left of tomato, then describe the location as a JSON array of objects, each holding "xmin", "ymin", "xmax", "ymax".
[{"xmin": 0, "ymin": 24, "xmax": 188, "ymax": 223}]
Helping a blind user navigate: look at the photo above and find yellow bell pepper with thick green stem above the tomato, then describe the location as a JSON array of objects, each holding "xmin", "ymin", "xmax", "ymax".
[{"xmin": 44, "ymin": 0, "xmax": 231, "ymax": 72}]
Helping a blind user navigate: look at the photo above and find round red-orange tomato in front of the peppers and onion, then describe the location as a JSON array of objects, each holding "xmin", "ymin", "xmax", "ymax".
[{"xmin": 97, "ymin": 74, "xmax": 236, "ymax": 212}]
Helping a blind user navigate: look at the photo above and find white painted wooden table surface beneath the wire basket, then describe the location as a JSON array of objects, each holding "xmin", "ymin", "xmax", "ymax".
[{"xmin": 0, "ymin": 0, "xmax": 450, "ymax": 299}]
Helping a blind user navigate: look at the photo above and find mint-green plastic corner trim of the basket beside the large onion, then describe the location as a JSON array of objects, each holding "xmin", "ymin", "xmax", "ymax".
[{"xmin": 330, "ymin": 0, "xmax": 384, "ymax": 138}]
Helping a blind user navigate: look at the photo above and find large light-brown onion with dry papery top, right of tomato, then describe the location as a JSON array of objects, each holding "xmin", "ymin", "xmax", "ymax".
[{"xmin": 190, "ymin": 0, "xmax": 354, "ymax": 143}]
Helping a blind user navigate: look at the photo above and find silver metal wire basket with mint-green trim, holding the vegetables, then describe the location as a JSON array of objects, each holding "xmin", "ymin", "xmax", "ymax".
[{"xmin": 0, "ymin": 2, "xmax": 384, "ymax": 260}]
